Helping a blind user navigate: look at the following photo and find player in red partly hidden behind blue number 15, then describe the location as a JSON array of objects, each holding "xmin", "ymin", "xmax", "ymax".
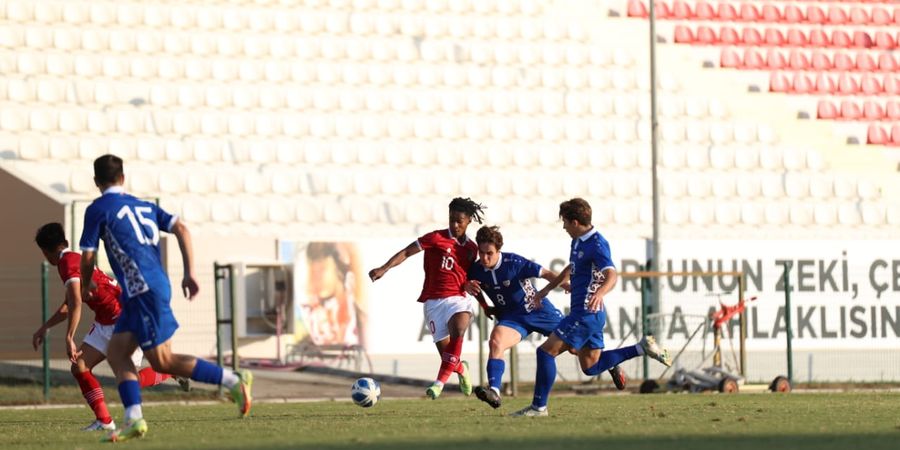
[{"xmin": 32, "ymin": 223, "xmax": 188, "ymax": 431}]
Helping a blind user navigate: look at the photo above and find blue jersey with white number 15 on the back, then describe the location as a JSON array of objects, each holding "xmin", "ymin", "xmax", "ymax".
[{"xmin": 80, "ymin": 186, "xmax": 177, "ymax": 299}]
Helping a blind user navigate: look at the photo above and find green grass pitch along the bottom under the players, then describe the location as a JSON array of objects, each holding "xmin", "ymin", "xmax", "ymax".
[{"xmin": 0, "ymin": 393, "xmax": 900, "ymax": 450}]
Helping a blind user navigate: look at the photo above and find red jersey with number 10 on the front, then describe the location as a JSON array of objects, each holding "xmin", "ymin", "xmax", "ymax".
[{"xmin": 416, "ymin": 230, "xmax": 478, "ymax": 302}]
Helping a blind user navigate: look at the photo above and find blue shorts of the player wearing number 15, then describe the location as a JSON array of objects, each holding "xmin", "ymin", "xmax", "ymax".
[{"xmin": 113, "ymin": 290, "xmax": 178, "ymax": 351}]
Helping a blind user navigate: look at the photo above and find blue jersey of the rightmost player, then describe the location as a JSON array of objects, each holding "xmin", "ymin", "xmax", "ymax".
[{"xmin": 569, "ymin": 229, "xmax": 616, "ymax": 312}]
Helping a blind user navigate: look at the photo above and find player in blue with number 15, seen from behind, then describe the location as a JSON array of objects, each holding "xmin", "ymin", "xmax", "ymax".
[{"xmin": 80, "ymin": 155, "xmax": 253, "ymax": 442}]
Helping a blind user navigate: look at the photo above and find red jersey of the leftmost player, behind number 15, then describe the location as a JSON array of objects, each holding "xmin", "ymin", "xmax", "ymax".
[{"xmin": 57, "ymin": 250, "xmax": 122, "ymax": 325}]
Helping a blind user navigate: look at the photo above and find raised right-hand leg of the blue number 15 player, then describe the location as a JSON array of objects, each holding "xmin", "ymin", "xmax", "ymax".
[{"xmin": 144, "ymin": 340, "xmax": 253, "ymax": 417}]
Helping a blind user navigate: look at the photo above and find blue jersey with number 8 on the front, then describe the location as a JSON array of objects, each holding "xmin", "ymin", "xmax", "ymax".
[{"xmin": 468, "ymin": 253, "xmax": 541, "ymax": 315}]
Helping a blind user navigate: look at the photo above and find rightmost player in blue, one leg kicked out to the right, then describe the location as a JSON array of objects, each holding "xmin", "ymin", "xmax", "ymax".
[{"xmin": 512, "ymin": 198, "xmax": 672, "ymax": 417}]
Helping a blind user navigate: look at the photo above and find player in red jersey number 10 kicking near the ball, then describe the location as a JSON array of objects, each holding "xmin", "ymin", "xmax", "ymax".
[{"xmin": 369, "ymin": 197, "xmax": 485, "ymax": 400}]
